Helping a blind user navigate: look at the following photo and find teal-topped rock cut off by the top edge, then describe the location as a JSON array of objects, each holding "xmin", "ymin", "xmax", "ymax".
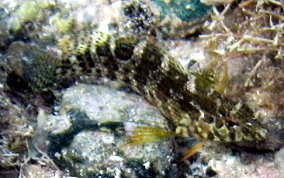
[{"xmin": 151, "ymin": 0, "xmax": 212, "ymax": 39}]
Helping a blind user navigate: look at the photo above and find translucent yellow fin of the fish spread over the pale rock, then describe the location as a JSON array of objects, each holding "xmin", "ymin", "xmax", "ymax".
[{"xmin": 128, "ymin": 126, "xmax": 174, "ymax": 145}]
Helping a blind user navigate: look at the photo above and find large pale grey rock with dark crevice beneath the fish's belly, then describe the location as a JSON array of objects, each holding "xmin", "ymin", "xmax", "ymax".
[{"xmin": 40, "ymin": 84, "xmax": 173, "ymax": 177}]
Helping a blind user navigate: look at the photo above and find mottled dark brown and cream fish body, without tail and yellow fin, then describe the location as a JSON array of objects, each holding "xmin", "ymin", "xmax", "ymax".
[{"xmin": 53, "ymin": 31, "xmax": 268, "ymax": 145}]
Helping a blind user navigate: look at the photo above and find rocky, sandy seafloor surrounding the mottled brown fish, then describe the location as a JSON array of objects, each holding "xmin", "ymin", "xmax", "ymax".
[{"xmin": 0, "ymin": 0, "xmax": 284, "ymax": 178}]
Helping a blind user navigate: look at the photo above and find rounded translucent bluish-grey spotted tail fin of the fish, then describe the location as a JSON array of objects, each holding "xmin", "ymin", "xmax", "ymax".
[{"xmin": 7, "ymin": 41, "xmax": 58, "ymax": 92}]
